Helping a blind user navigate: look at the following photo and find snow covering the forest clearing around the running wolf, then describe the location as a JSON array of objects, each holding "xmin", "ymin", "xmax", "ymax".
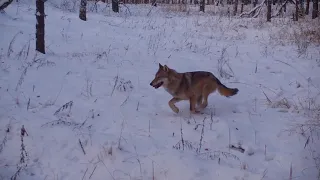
[{"xmin": 0, "ymin": 3, "xmax": 320, "ymax": 180}]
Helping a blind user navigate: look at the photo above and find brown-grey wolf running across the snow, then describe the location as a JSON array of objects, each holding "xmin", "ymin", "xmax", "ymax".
[{"xmin": 150, "ymin": 63, "xmax": 239, "ymax": 114}]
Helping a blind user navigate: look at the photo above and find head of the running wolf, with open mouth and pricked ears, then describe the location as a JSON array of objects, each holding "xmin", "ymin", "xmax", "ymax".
[{"xmin": 150, "ymin": 63, "xmax": 170, "ymax": 89}]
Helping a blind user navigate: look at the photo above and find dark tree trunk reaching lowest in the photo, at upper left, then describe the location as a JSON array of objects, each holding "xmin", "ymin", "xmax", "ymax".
[{"xmin": 36, "ymin": 0, "xmax": 46, "ymax": 54}]
